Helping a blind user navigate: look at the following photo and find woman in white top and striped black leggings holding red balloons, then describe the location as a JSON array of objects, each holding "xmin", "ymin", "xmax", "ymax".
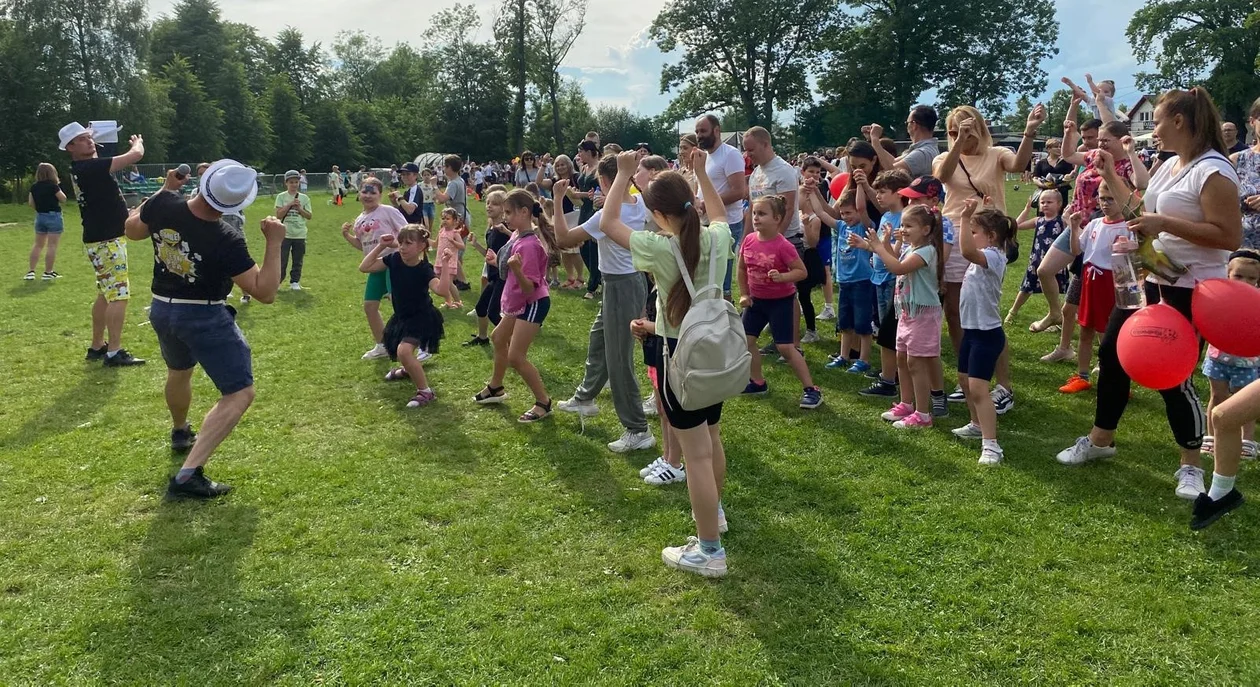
[{"xmin": 1058, "ymin": 87, "xmax": 1242, "ymax": 511}]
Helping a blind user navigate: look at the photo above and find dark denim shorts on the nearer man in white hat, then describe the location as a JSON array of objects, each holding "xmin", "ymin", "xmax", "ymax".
[{"xmin": 149, "ymin": 299, "xmax": 253, "ymax": 396}]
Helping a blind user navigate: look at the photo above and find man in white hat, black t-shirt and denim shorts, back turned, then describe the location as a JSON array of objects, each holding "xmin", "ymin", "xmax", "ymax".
[{"xmin": 127, "ymin": 160, "xmax": 285, "ymax": 498}]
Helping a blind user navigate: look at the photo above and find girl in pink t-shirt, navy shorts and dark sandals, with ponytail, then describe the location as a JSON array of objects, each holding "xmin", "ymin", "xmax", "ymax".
[{"xmin": 473, "ymin": 189, "xmax": 556, "ymax": 422}]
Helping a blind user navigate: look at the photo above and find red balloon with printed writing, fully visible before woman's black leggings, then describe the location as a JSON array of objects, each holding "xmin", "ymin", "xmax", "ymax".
[{"xmin": 1115, "ymin": 303, "xmax": 1198, "ymax": 391}]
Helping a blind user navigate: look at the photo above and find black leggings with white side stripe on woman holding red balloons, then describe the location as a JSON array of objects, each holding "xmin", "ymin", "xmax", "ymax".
[{"xmin": 1094, "ymin": 281, "xmax": 1207, "ymax": 449}]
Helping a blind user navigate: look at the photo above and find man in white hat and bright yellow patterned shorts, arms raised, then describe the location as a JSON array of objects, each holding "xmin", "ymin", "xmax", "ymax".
[{"xmin": 58, "ymin": 122, "xmax": 145, "ymax": 367}]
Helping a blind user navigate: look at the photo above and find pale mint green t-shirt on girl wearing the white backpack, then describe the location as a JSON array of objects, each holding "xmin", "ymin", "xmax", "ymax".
[{"xmin": 630, "ymin": 222, "xmax": 733, "ymax": 339}]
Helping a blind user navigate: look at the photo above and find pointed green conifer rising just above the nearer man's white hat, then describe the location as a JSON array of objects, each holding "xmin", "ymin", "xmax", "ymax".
[{"xmin": 163, "ymin": 57, "xmax": 223, "ymax": 163}]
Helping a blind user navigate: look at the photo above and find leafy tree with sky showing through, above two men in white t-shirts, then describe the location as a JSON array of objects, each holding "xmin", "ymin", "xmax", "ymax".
[{"xmin": 649, "ymin": 0, "xmax": 840, "ymax": 126}]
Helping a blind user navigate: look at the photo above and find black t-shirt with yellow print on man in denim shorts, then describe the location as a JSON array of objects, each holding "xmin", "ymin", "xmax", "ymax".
[{"xmin": 140, "ymin": 190, "xmax": 255, "ymax": 300}]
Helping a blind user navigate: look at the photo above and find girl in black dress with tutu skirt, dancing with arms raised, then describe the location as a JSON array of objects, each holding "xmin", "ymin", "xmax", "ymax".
[{"xmin": 359, "ymin": 224, "xmax": 452, "ymax": 408}]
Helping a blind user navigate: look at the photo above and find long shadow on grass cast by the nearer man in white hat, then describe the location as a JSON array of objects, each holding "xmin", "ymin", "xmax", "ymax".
[{"xmin": 87, "ymin": 497, "xmax": 310, "ymax": 684}]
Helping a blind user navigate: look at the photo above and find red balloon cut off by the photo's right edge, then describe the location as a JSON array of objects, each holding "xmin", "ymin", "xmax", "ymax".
[{"xmin": 1191, "ymin": 279, "xmax": 1260, "ymax": 358}]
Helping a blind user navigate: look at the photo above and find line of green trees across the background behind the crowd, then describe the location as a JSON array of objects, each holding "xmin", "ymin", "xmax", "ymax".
[{"xmin": 0, "ymin": 0, "xmax": 1260, "ymax": 186}]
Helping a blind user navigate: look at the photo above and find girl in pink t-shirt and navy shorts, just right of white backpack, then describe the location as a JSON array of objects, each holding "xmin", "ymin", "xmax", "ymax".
[{"xmin": 736, "ymin": 195, "xmax": 823, "ymax": 410}]
